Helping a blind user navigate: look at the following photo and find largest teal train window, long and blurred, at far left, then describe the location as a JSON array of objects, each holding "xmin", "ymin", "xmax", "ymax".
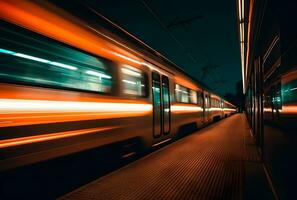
[{"xmin": 0, "ymin": 23, "xmax": 112, "ymax": 93}]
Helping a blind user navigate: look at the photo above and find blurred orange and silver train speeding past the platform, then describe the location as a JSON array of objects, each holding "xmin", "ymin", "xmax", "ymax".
[{"xmin": 0, "ymin": 1, "xmax": 236, "ymax": 171}]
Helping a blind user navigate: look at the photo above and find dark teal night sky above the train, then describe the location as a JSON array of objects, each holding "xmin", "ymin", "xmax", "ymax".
[{"xmin": 87, "ymin": 0, "xmax": 241, "ymax": 95}]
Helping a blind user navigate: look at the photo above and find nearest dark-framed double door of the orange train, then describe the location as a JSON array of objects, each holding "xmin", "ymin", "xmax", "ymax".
[{"xmin": 152, "ymin": 72, "xmax": 171, "ymax": 137}]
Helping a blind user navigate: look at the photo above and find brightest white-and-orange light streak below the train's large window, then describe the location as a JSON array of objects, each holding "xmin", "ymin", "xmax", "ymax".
[{"xmin": 0, "ymin": 99, "xmax": 152, "ymax": 127}]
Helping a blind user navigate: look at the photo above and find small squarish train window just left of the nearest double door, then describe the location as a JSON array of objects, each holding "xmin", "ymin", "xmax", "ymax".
[{"xmin": 121, "ymin": 65, "xmax": 146, "ymax": 97}]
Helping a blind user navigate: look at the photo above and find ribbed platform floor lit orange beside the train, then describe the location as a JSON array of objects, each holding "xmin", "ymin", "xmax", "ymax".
[{"xmin": 61, "ymin": 114, "xmax": 274, "ymax": 200}]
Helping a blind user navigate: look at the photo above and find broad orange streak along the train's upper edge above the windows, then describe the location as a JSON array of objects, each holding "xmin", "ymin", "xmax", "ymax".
[{"xmin": 0, "ymin": 0, "xmax": 141, "ymax": 66}]
